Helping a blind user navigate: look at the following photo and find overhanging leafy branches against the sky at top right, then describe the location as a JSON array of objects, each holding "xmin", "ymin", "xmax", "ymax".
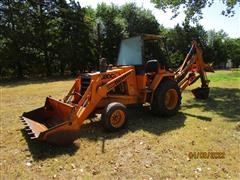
[{"xmin": 151, "ymin": 0, "xmax": 240, "ymax": 22}]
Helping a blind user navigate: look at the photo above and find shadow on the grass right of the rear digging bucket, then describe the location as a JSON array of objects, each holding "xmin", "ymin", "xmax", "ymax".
[{"xmin": 182, "ymin": 87, "xmax": 240, "ymax": 121}]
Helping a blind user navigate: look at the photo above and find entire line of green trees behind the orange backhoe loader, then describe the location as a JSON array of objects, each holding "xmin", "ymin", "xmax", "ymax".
[{"xmin": 0, "ymin": 0, "xmax": 240, "ymax": 79}]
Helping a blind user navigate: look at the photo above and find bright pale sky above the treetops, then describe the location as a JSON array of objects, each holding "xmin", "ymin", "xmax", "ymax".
[{"xmin": 78, "ymin": 0, "xmax": 240, "ymax": 38}]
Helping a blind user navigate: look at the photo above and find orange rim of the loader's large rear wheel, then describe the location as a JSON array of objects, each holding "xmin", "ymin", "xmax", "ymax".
[{"xmin": 164, "ymin": 89, "xmax": 178, "ymax": 110}]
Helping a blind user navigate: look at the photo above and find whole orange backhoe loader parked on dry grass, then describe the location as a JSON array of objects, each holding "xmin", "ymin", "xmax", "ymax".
[{"xmin": 20, "ymin": 34, "xmax": 213, "ymax": 145}]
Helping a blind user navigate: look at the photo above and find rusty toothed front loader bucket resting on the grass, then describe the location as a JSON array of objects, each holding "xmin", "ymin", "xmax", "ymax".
[{"xmin": 20, "ymin": 97, "xmax": 77, "ymax": 145}]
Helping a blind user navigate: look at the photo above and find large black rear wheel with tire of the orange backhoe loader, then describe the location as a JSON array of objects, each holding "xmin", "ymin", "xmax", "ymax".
[{"xmin": 151, "ymin": 80, "xmax": 182, "ymax": 116}]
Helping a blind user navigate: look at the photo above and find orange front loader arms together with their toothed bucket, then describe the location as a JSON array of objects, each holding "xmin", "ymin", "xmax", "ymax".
[{"xmin": 20, "ymin": 69, "xmax": 135, "ymax": 145}]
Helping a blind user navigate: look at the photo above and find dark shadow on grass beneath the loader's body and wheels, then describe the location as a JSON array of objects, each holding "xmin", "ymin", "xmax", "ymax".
[{"xmin": 79, "ymin": 106, "xmax": 186, "ymax": 141}]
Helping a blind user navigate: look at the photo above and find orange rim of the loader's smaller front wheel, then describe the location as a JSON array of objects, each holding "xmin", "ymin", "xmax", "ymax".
[{"xmin": 110, "ymin": 110, "xmax": 125, "ymax": 128}]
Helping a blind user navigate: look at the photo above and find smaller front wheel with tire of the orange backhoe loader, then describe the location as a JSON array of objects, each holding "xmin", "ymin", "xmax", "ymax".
[{"xmin": 101, "ymin": 102, "xmax": 127, "ymax": 131}]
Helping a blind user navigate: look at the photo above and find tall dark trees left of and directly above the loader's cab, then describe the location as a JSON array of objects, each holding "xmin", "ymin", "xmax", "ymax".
[{"xmin": 0, "ymin": 0, "xmax": 159, "ymax": 78}]
